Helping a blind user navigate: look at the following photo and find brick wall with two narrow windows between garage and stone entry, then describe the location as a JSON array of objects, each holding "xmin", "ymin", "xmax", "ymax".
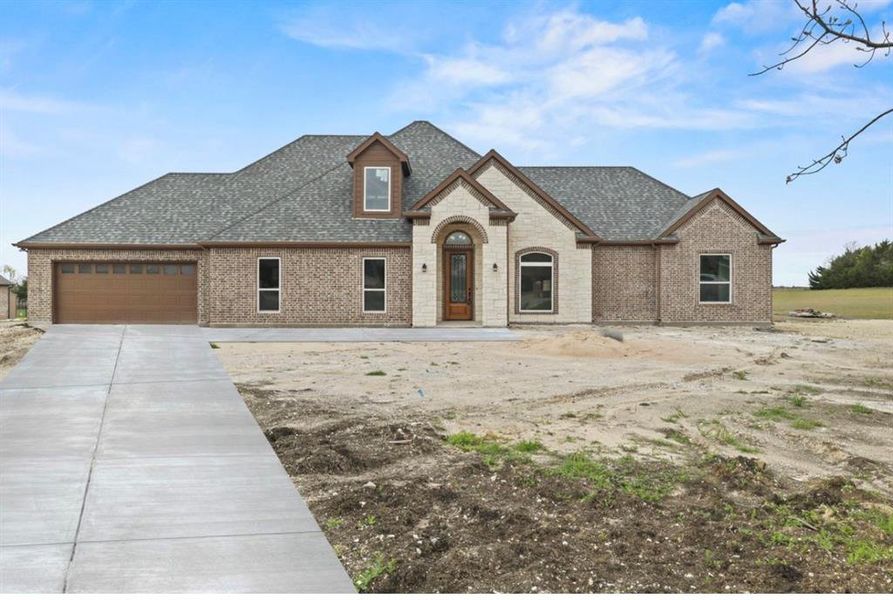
[{"xmin": 208, "ymin": 248, "xmax": 412, "ymax": 326}]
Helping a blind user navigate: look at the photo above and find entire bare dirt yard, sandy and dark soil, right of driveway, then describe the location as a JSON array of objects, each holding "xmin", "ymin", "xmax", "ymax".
[{"xmin": 218, "ymin": 321, "xmax": 893, "ymax": 592}]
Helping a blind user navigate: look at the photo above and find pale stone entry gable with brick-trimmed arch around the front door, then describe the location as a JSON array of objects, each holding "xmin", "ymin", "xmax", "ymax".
[{"xmin": 412, "ymin": 183, "xmax": 507, "ymax": 327}]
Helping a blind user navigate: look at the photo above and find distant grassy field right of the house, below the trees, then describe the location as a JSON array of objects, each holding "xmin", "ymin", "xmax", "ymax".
[{"xmin": 772, "ymin": 288, "xmax": 893, "ymax": 319}]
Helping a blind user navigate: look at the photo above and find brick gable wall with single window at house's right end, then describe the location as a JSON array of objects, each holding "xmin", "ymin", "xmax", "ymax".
[{"xmin": 659, "ymin": 200, "xmax": 772, "ymax": 323}]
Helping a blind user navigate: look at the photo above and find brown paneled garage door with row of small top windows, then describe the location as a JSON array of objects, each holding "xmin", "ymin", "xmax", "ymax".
[{"xmin": 54, "ymin": 262, "xmax": 198, "ymax": 323}]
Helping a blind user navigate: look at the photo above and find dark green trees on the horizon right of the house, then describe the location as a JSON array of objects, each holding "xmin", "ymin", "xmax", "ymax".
[{"xmin": 809, "ymin": 240, "xmax": 893, "ymax": 290}]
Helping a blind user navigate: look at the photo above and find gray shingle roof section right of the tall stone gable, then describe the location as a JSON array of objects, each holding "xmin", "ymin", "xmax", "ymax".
[{"xmin": 519, "ymin": 167, "xmax": 690, "ymax": 240}]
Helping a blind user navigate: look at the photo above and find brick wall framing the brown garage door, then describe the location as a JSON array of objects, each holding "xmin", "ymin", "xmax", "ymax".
[{"xmin": 28, "ymin": 248, "xmax": 208, "ymax": 325}]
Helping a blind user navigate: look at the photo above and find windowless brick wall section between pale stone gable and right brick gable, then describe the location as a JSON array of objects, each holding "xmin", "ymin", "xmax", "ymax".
[{"xmin": 592, "ymin": 246, "xmax": 657, "ymax": 321}]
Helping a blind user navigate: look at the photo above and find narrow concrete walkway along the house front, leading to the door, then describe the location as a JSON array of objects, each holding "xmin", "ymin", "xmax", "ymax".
[{"xmin": 202, "ymin": 327, "xmax": 520, "ymax": 342}]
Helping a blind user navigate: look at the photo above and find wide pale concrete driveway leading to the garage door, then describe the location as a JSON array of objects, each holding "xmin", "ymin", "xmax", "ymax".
[{"xmin": 0, "ymin": 325, "xmax": 353, "ymax": 592}]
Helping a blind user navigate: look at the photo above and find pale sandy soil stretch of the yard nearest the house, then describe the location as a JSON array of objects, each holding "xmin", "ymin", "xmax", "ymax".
[{"xmin": 220, "ymin": 321, "xmax": 893, "ymax": 492}]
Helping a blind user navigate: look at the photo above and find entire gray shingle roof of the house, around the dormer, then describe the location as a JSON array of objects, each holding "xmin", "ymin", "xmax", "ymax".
[{"xmin": 20, "ymin": 121, "xmax": 716, "ymax": 244}]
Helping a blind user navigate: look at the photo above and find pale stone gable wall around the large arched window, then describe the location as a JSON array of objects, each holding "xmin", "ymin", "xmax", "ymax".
[{"xmin": 476, "ymin": 163, "xmax": 592, "ymax": 323}]
